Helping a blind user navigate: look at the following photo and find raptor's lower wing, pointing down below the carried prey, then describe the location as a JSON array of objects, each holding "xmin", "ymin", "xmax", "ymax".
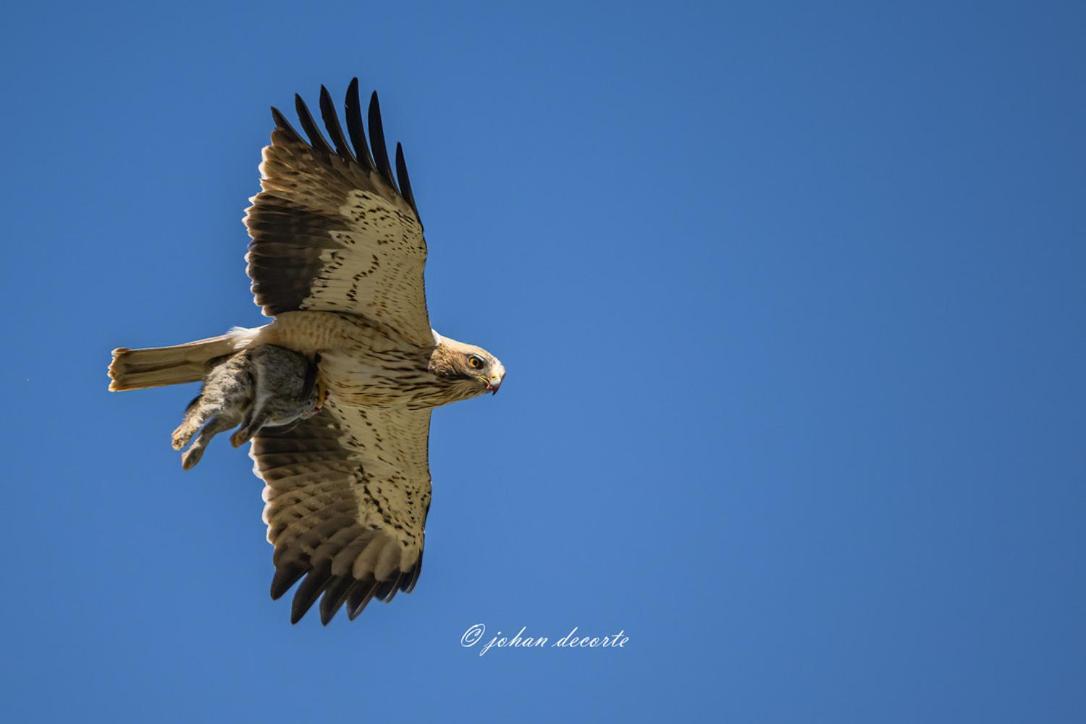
[{"xmin": 250, "ymin": 399, "xmax": 430, "ymax": 624}]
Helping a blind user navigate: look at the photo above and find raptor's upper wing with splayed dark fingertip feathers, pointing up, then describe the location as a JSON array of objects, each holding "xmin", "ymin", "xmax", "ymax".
[{"xmin": 244, "ymin": 78, "xmax": 433, "ymax": 344}]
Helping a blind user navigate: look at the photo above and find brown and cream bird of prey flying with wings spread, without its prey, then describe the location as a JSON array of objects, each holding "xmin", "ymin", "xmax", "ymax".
[{"xmin": 109, "ymin": 78, "xmax": 505, "ymax": 623}]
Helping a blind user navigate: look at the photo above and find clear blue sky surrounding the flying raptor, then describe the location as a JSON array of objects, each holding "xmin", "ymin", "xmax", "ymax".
[{"xmin": 0, "ymin": 2, "xmax": 1086, "ymax": 724}]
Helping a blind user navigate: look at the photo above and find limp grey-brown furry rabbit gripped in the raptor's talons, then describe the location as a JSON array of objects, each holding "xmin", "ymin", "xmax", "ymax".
[{"xmin": 172, "ymin": 344, "xmax": 323, "ymax": 470}]
